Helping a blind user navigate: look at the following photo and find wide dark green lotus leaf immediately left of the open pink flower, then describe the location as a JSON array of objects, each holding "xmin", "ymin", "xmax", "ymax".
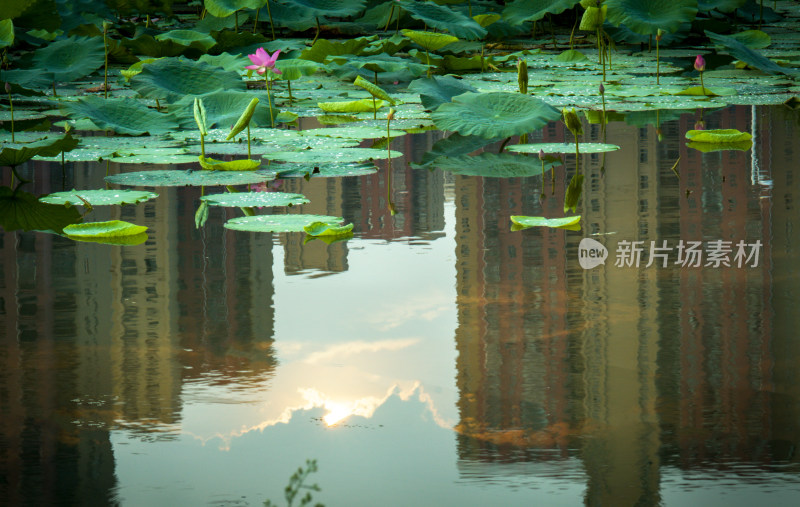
[{"xmin": 130, "ymin": 58, "xmax": 246, "ymax": 102}]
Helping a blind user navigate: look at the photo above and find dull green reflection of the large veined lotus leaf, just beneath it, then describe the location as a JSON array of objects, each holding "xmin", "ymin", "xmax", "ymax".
[{"xmin": 422, "ymin": 152, "xmax": 561, "ymax": 178}]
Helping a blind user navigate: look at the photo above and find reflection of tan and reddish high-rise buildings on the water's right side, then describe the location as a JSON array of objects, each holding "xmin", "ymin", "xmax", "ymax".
[{"xmin": 456, "ymin": 108, "xmax": 800, "ymax": 505}]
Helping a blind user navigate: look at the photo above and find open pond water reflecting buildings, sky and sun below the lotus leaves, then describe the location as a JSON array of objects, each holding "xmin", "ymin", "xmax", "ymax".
[{"xmin": 0, "ymin": 106, "xmax": 800, "ymax": 506}]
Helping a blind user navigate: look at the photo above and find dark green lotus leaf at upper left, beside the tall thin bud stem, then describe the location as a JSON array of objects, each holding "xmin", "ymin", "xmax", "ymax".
[{"xmin": 33, "ymin": 36, "xmax": 105, "ymax": 82}]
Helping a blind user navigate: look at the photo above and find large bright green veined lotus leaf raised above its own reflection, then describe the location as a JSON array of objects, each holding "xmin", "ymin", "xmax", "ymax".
[{"xmin": 431, "ymin": 92, "xmax": 561, "ymax": 139}]
